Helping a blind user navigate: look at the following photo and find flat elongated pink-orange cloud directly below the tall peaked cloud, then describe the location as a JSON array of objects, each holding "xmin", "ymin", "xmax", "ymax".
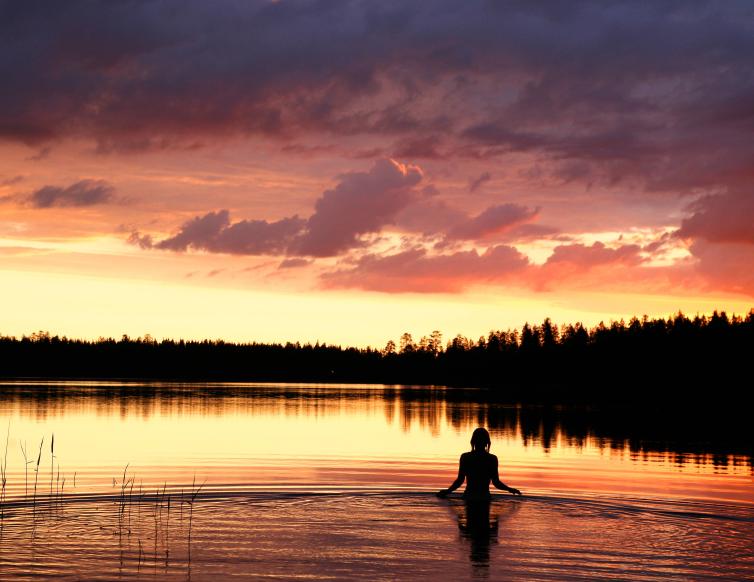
[{"xmin": 321, "ymin": 245, "xmax": 529, "ymax": 293}]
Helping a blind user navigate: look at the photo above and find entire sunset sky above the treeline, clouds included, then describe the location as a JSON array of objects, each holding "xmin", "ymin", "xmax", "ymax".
[{"xmin": 0, "ymin": 0, "xmax": 754, "ymax": 347}]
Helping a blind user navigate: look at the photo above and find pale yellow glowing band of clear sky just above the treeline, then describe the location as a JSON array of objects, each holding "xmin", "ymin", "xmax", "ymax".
[{"xmin": 0, "ymin": 271, "xmax": 751, "ymax": 348}]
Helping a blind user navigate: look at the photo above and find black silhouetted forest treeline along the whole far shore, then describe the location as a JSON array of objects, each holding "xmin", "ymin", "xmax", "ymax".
[{"xmin": 0, "ymin": 310, "xmax": 754, "ymax": 402}]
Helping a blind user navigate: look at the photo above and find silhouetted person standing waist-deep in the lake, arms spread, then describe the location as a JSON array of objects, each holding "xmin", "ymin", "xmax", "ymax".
[{"xmin": 437, "ymin": 428, "xmax": 521, "ymax": 499}]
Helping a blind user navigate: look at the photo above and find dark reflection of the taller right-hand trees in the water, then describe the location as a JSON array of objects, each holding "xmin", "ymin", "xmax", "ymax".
[{"xmin": 398, "ymin": 391, "xmax": 754, "ymax": 472}]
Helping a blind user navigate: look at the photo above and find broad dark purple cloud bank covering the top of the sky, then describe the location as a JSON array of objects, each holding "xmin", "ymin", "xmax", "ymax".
[{"xmin": 0, "ymin": 0, "xmax": 754, "ymax": 201}]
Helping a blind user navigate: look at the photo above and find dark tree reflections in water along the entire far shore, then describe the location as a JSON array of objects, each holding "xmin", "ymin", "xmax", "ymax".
[{"xmin": 0, "ymin": 383, "xmax": 754, "ymax": 472}]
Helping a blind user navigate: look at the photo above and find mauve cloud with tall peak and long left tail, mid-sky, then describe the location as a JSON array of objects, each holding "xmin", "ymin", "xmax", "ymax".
[{"xmin": 145, "ymin": 159, "xmax": 549, "ymax": 257}]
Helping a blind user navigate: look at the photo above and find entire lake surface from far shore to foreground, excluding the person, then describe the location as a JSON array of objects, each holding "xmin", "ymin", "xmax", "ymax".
[{"xmin": 0, "ymin": 382, "xmax": 754, "ymax": 580}]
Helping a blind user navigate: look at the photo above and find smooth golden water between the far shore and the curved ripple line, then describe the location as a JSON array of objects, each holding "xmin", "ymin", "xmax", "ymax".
[{"xmin": 0, "ymin": 383, "xmax": 754, "ymax": 502}]
